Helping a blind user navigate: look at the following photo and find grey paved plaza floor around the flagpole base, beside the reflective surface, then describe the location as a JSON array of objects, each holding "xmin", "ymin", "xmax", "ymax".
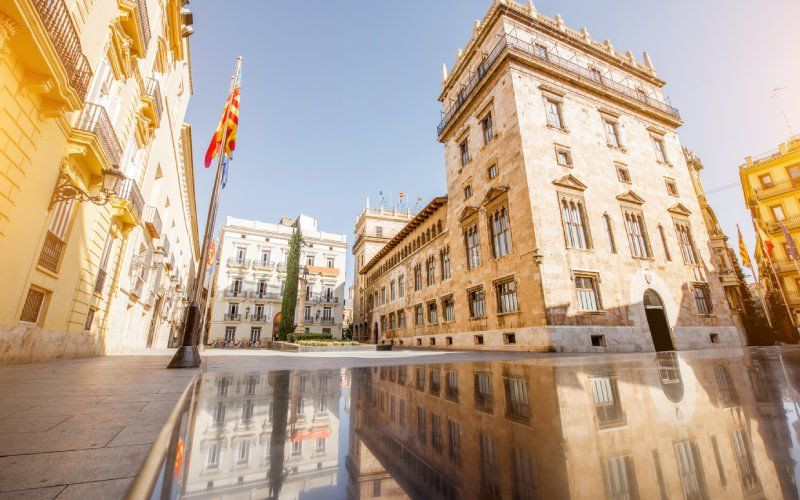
[{"xmin": 0, "ymin": 350, "xmax": 552, "ymax": 500}]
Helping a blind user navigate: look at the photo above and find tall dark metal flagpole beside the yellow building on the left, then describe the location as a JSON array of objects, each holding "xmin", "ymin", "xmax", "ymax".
[{"xmin": 167, "ymin": 56, "xmax": 242, "ymax": 368}]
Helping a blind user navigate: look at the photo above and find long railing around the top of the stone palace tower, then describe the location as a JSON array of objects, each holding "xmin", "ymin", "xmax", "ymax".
[{"xmin": 436, "ymin": 34, "xmax": 680, "ymax": 135}]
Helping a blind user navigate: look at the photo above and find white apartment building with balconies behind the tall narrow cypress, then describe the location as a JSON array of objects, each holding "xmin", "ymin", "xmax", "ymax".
[{"xmin": 208, "ymin": 214, "xmax": 347, "ymax": 345}]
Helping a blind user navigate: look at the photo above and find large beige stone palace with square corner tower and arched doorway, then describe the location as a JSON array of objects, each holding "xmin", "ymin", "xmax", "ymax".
[{"xmin": 354, "ymin": 0, "xmax": 742, "ymax": 351}]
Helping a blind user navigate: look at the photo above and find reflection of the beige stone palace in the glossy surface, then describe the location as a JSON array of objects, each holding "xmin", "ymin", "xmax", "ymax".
[{"xmin": 347, "ymin": 353, "xmax": 794, "ymax": 499}]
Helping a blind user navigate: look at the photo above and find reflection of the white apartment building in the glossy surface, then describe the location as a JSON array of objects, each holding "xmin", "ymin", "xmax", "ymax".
[{"xmin": 184, "ymin": 370, "xmax": 342, "ymax": 498}]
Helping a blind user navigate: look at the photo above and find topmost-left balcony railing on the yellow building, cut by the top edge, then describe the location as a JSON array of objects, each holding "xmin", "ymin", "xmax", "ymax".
[{"xmin": 33, "ymin": 0, "xmax": 92, "ymax": 102}]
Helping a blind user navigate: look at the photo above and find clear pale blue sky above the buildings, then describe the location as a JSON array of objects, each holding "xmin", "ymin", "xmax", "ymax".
[{"xmin": 187, "ymin": 0, "xmax": 800, "ymax": 281}]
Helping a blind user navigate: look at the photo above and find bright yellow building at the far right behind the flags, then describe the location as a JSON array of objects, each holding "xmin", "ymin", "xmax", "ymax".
[{"xmin": 739, "ymin": 135, "xmax": 800, "ymax": 342}]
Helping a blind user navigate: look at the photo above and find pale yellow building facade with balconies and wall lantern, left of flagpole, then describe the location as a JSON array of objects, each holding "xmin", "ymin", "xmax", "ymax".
[{"xmin": 0, "ymin": 0, "xmax": 199, "ymax": 363}]
